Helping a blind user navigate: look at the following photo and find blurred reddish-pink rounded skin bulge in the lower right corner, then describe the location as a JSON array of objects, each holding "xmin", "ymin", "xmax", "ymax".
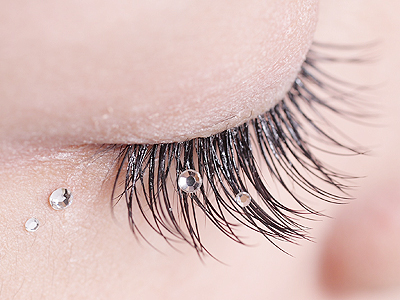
[{"xmin": 321, "ymin": 182, "xmax": 400, "ymax": 294}]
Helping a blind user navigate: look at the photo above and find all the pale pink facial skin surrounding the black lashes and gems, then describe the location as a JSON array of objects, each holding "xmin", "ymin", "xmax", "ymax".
[{"xmin": 0, "ymin": 0, "xmax": 400, "ymax": 299}]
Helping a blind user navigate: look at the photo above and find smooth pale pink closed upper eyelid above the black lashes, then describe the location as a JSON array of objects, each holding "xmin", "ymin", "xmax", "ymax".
[{"xmin": 0, "ymin": 0, "xmax": 318, "ymax": 145}]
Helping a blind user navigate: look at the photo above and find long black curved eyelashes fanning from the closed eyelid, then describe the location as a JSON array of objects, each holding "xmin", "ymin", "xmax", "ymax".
[{"xmin": 112, "ymin": 44, "xmax": 368, "ymax": 254}]
